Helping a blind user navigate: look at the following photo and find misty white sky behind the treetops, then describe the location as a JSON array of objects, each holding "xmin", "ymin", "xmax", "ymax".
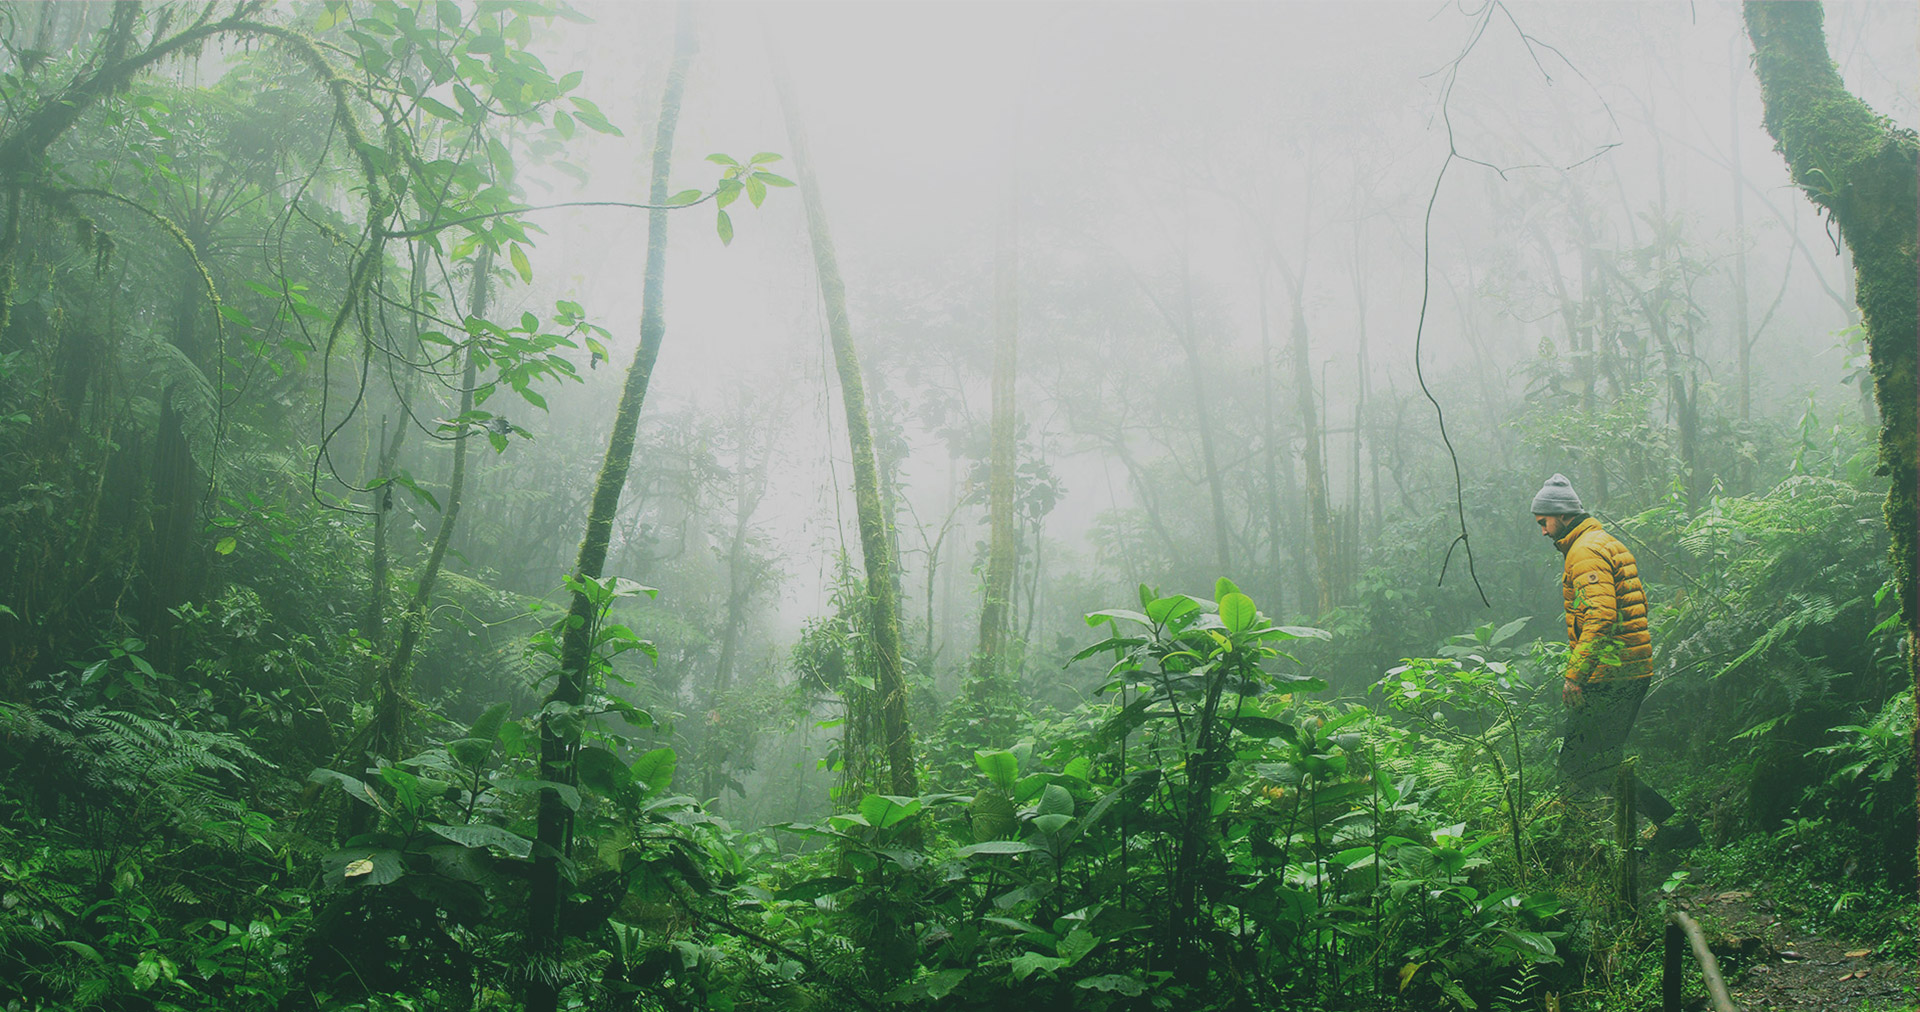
[{"xmin": 456, "ymin": 2, "xmax": 1920, "ymax": 616}]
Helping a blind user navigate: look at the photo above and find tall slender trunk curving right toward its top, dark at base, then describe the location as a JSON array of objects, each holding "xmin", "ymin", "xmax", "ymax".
[{"xmin": 526, "ymin": 6, "xmax": 693, "ymax": 1012}]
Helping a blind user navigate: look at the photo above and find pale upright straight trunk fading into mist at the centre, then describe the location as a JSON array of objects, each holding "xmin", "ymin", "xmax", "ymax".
[{"xmin": 972, "ymin": 168, "xmax": 1020, "ymax": 703}]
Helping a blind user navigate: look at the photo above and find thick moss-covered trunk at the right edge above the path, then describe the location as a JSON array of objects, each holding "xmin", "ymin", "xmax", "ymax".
[{"xmin": 1745, "ymin": 2, "xmax": 1920, "ymax": 898}]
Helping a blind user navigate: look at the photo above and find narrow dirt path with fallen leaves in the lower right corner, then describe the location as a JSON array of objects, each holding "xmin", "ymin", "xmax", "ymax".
[{"xmin": 1680, "ymin": 885, "xmax": 1920, "ymax": 1012}]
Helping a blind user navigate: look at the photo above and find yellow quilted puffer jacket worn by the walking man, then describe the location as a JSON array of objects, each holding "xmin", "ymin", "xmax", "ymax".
[{"xmin": 1553, "ymin": 517, "xmax": 1653, "ymax": 684}]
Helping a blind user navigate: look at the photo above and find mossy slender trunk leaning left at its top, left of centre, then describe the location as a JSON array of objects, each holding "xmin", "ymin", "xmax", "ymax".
[{"xmin": 776, "ymin": 59, "xmax": 920, "ymax": 795}]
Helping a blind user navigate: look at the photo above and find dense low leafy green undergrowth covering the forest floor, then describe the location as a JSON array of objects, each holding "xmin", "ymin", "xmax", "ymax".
[{"xmin": 0, "ymin": 468, "xmax": 1914, "ymax": 1010}]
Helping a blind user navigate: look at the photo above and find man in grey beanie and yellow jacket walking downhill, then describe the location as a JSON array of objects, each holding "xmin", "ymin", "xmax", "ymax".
[{"xmin": 1534, "ymin": 474, "xmax": 1699, "ymax": 847}]
